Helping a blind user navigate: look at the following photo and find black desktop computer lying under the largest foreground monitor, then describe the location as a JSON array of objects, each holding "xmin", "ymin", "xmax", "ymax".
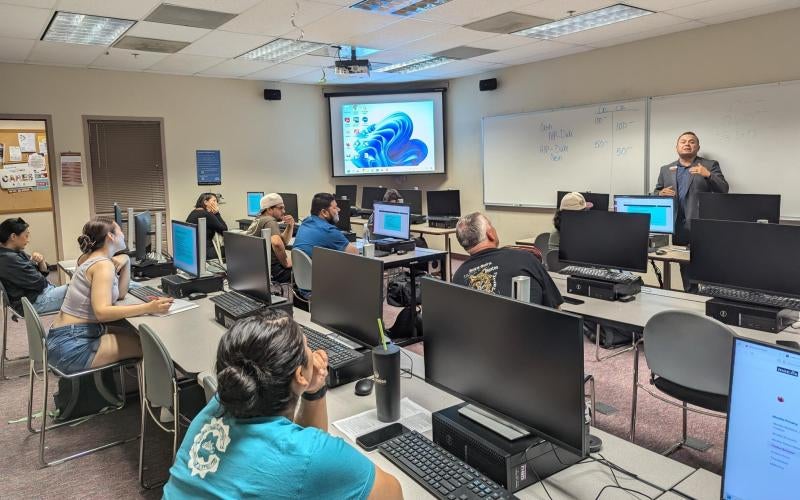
[{"xmin": 432, "ymin": 403, "xmax": 588, "ymax": 493}]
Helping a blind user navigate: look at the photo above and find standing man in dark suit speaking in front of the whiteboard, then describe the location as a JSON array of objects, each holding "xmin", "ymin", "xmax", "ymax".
[{"xmin": 655, "ymin": 132, "xmax": 728, "ymax": 290}]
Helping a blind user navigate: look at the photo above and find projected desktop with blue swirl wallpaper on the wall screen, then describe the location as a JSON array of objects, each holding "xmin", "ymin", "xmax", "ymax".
[{"xmin": 342, "ymin": 101, "xmax": 435, "ymax": 174}]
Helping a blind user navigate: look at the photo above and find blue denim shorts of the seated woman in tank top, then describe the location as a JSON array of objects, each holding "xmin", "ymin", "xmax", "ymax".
[{"xmin": 47, "ymin": 323, "xmax": 106, "ymax": 373}]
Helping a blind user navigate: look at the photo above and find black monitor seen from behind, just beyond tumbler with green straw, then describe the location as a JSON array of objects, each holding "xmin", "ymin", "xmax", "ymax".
[{"xmin": 311, "ymin": 247, "xmax": 383, "ymax": 347}]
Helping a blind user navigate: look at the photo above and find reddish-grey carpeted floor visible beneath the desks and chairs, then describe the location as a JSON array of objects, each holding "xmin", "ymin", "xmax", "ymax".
[{"xmin": 0, "ymin": 262, "xmax": 725, "ymax": 499}]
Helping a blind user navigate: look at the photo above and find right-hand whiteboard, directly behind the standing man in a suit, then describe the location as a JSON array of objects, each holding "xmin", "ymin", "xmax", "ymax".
[{"xmin": 650, "ymin": 82, "xmax": 800, "ymax": 218}]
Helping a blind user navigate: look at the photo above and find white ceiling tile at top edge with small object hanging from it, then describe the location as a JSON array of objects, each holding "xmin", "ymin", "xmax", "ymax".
[{"xmin": 220, "ymin": 0, "xmax": 341, "ymax": 40}]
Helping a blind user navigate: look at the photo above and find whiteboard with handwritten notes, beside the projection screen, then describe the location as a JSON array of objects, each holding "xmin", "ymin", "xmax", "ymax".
[{"xmin": 481, "ymin": 99, "xmax": 647, "ymax": 208}]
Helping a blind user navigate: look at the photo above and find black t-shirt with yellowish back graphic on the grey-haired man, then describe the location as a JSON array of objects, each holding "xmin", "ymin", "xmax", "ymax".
[{"xmin": 453, "ymin": 248, "xmax": 564, "ymax": 307}]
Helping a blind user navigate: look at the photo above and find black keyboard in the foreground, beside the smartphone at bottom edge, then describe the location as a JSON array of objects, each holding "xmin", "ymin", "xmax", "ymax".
[{"xmin": 379, "ymin": 432, "xmax": 516, "ymax": 500}]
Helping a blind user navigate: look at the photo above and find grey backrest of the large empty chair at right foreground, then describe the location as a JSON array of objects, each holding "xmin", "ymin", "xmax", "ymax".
[{"xmin": 644, "ymin": 310, "xmax": 736, "ymax": 396}]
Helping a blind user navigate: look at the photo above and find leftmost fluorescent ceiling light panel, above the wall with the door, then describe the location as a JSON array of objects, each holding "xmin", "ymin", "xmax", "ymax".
[{"xmin": 42, "ymin": 12, "xmax": 135, "ymax": 45}]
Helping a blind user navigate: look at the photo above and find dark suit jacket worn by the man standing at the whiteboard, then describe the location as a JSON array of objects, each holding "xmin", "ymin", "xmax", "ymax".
[{"xmin": 655, "ymin": 156, "xmax": 729, "ymax": 244}]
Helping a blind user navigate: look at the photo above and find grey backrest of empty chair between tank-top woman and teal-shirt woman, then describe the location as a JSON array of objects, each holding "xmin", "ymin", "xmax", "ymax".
[{"xmin": 139, "ymin": 325, "xmax": 175, "ymax": 408}]
